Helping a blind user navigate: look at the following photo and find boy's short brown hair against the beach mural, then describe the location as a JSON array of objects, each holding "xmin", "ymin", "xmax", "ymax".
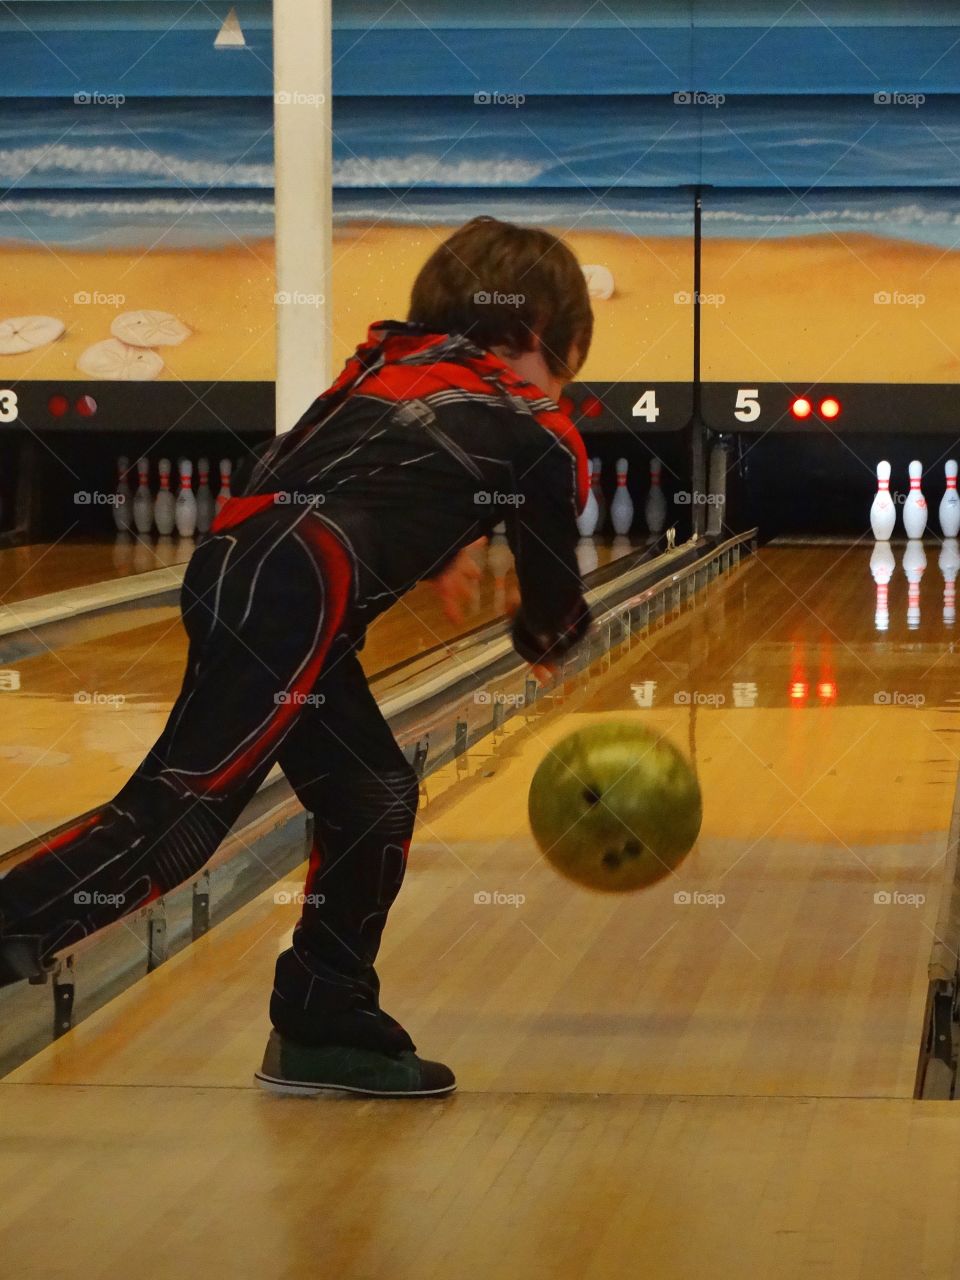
[{"xmin": 408, "ymin": 218, "xmax": 594, "ymax": 379}]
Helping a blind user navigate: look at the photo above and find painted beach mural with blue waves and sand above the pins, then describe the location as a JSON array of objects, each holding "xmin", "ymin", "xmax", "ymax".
[{"xmin": 0, "ymin": 0, "xmax": 960, "ymax": 399}]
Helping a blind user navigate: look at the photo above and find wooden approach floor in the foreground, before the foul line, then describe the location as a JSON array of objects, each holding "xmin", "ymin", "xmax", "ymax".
[{"xmin": 0, "ymin": 1084, "xmax": 960, "ymax": 1280}]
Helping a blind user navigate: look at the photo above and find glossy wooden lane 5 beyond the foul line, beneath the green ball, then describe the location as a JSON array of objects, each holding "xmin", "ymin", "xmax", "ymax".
[{"xmin": 5, "ymin": 549, "xmax": 956, "ymax": 1098}]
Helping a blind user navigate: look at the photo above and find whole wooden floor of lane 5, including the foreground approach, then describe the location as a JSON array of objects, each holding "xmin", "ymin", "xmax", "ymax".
[{"xmin": 0, "ymin": 550, "xmax": 960, "ymax": 1280}]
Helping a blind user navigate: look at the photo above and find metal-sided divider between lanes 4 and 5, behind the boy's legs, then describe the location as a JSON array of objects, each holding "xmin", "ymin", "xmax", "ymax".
[{"xmin": 0, "ymin": 529, "xmax": 756, "ymax": 1075}]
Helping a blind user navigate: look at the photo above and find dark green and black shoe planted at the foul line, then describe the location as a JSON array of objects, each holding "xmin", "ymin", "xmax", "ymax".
[{"xmin": 255, "ymin": 1032, "xmax": 457, "ymax": 1098}]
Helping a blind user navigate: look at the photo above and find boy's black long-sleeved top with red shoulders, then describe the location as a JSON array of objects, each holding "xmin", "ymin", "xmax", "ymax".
[{"xmin": 214, "ymin": 321, "xmax": 590, "ymax": 662}]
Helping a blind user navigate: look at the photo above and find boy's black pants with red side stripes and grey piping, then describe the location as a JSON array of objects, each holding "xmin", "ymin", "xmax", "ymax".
[{"xmin": 0, "ymin": 499, "xmax": 417, "ymax": 1050}]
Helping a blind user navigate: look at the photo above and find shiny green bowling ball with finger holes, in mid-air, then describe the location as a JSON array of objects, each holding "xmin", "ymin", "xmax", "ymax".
[{"xmin": 529, "ymin": 719, "xmax": 703, "ymax": 893}]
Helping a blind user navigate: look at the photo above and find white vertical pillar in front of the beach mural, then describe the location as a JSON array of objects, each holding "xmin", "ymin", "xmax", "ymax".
[{"xmin": 273, "ymin": 0, "xmax": 333, "ymax": 431}]
